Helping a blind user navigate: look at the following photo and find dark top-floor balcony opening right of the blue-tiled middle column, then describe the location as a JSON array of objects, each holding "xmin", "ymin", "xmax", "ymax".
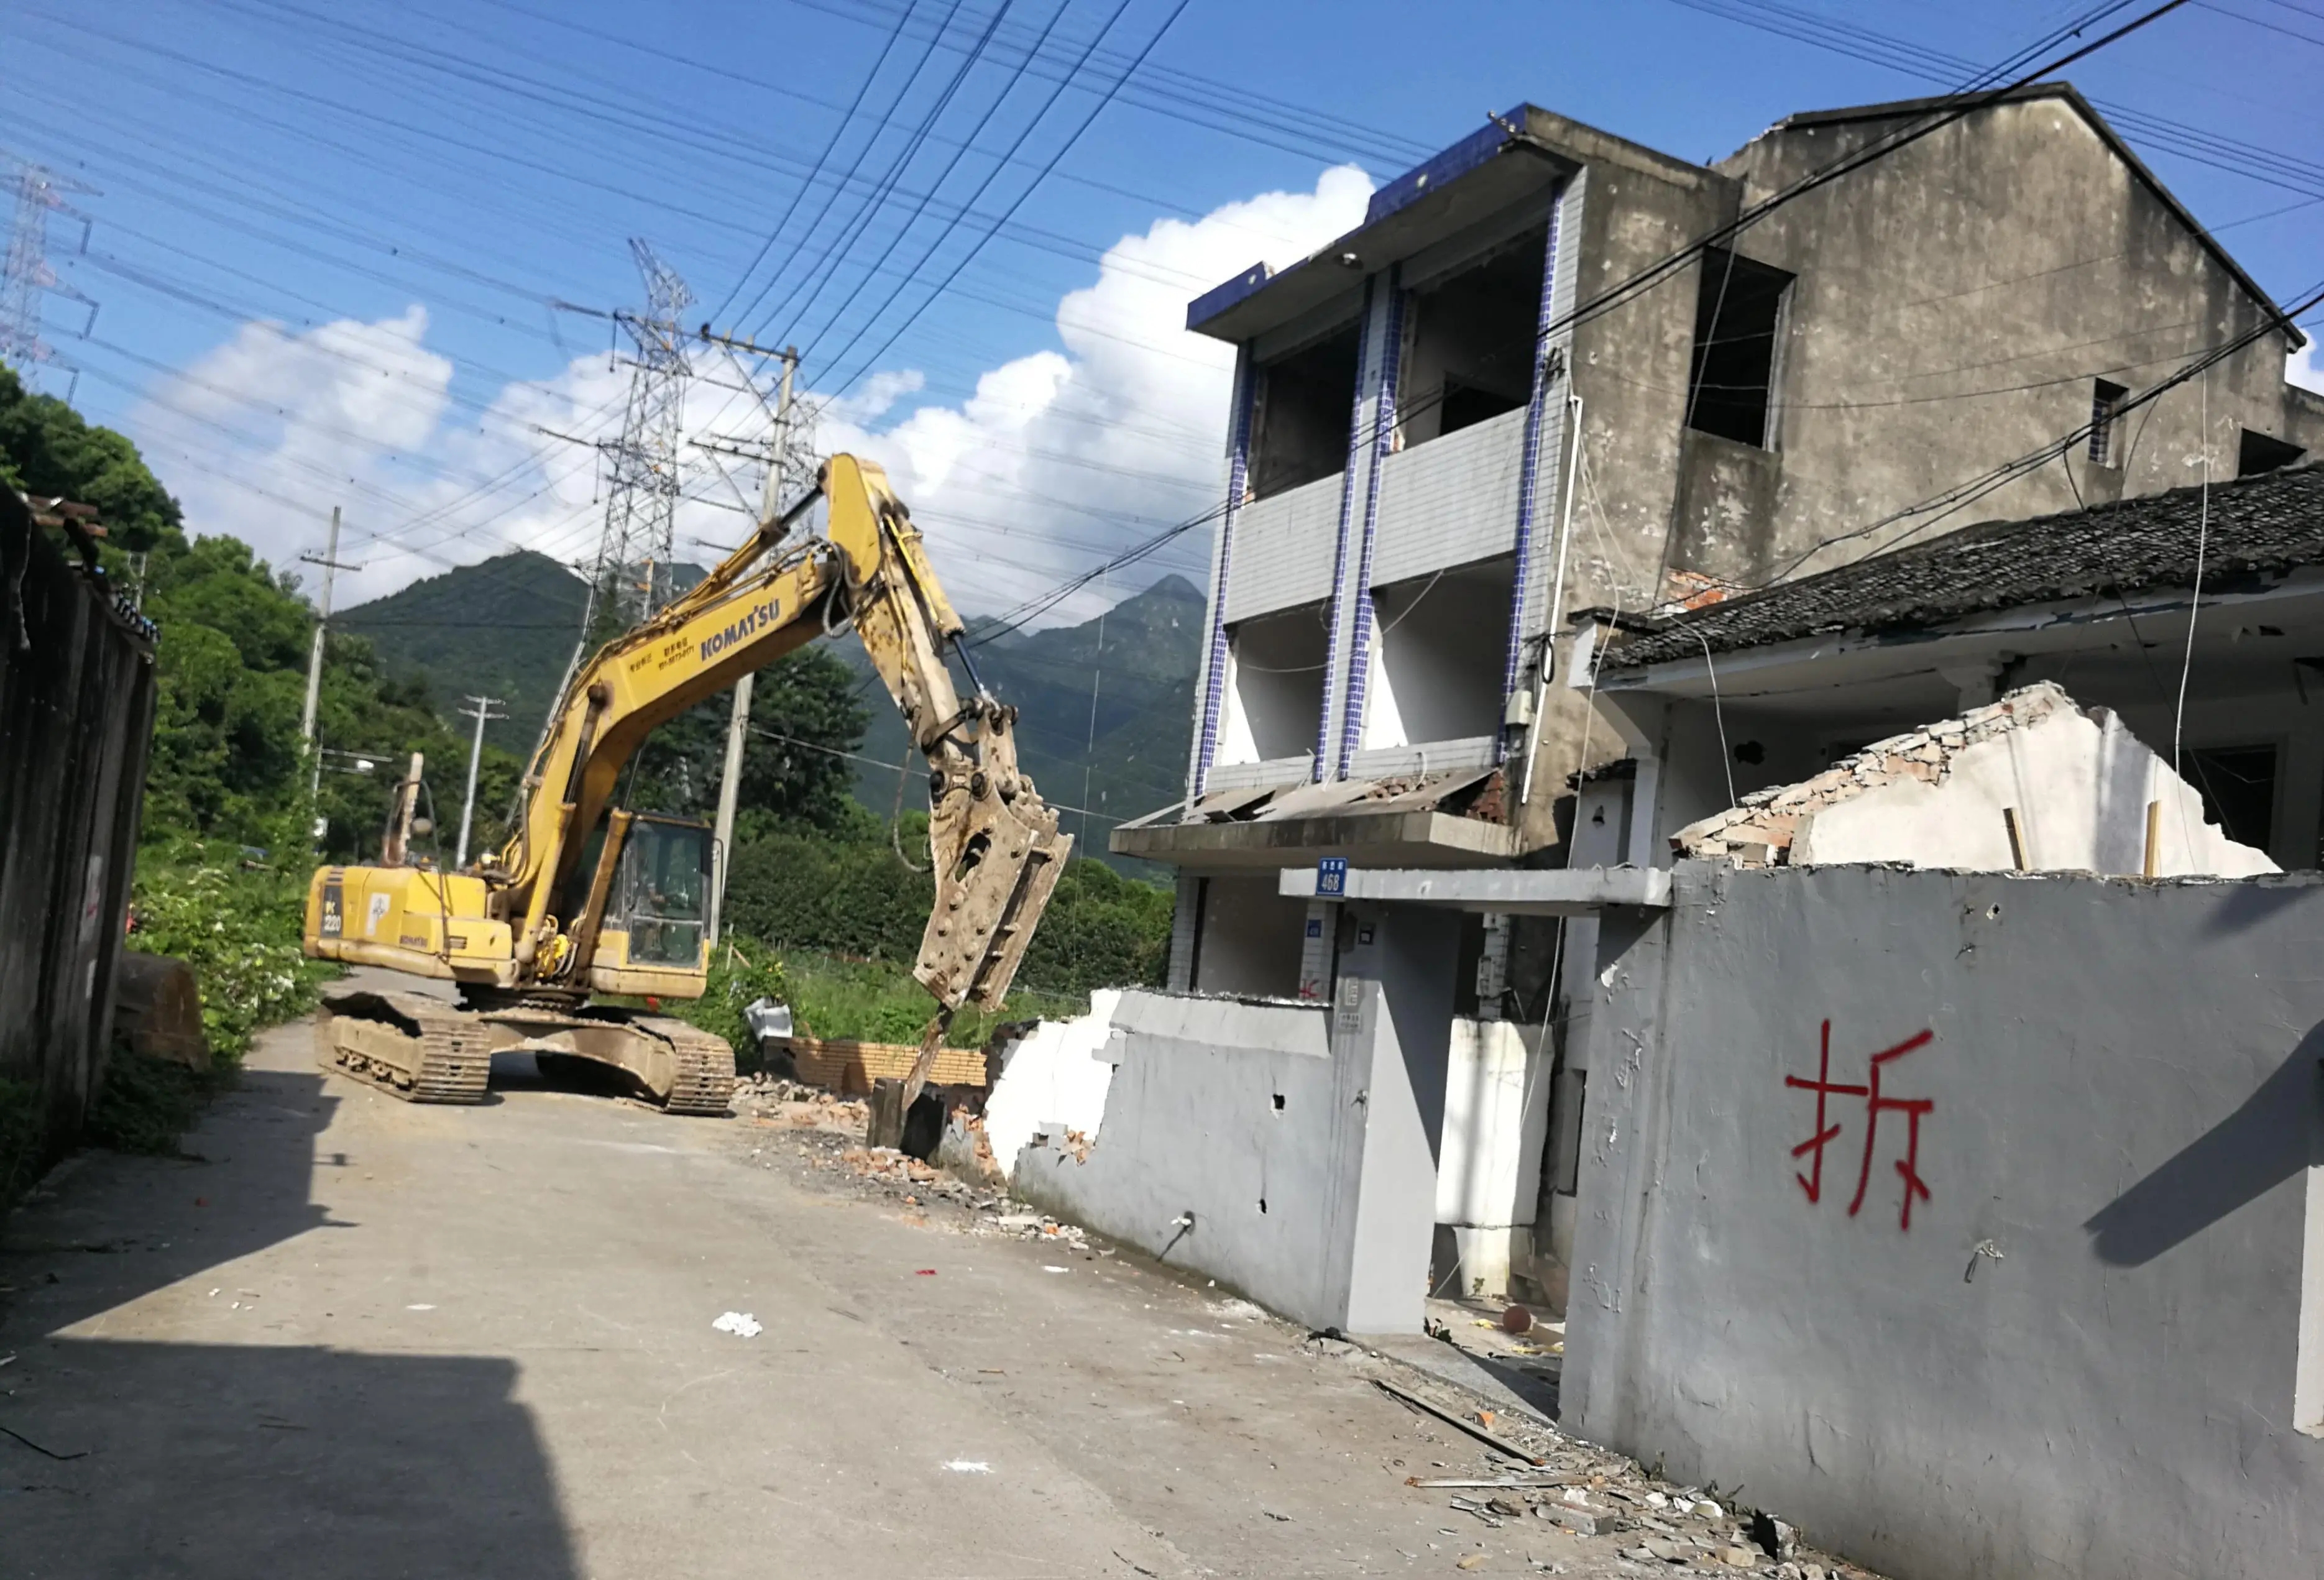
[{"xmin": 1399, "ymin": 223, "xmax": 1550, "ymax": 446}]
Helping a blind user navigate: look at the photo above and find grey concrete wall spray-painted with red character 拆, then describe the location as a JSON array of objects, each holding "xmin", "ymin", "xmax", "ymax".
[{"xmin": 1564, "ymin": 862, "xmax": 2324, "ymax": 1580}]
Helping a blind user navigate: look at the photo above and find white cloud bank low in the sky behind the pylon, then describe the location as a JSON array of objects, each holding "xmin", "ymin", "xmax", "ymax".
[{"xmin": 128, "ymin": 167, "xmax": 1371, "ymax": 618}]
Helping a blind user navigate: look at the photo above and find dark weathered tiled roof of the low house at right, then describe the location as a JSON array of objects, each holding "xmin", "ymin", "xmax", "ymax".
[{"xmin": 1606, "ymin": 462, "xmax": 2324, "ymax": 669}]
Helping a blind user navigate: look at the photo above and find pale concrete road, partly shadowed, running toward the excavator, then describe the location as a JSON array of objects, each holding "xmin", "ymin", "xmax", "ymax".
[{"xmin": 0, "ymin": 980, "xmax": 1747, "ymax": 1580}]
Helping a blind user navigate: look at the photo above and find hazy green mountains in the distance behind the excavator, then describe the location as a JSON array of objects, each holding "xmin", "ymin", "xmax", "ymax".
[{"xmin": 333, "ymin": 551, "xmax": 1204, "ymax": 855}]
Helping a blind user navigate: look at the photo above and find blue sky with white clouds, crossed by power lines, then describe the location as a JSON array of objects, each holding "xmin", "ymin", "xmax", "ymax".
[{"xmin": 0, "ymin": 0, "xmax": 2324, "ymax": 613}]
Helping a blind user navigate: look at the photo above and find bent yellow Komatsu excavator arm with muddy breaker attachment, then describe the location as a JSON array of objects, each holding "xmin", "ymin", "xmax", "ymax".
[{"xmin": 493, "ymin": 456, "xmax": 1073, "ymax": 1011}]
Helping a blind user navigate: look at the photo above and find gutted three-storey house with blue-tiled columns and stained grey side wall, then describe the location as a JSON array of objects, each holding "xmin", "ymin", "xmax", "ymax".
[{"xmin": 1113, "ymin": 84, "xmax": 2324, "ymax": 999}]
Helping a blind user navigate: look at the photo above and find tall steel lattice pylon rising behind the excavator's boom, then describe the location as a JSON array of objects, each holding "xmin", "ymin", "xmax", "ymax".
[{"xmin": 590, "ymin": 237, "xmax": 695, "ymax": 630}]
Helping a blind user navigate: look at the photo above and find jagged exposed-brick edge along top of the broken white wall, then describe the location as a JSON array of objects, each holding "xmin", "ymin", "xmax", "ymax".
[{"xmin": 1671, "ymin": 681, "xmax": 2080, "ymax": 866}]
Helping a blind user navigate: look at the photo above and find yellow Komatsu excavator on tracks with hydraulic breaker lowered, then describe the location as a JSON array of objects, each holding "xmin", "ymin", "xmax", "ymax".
[{"xmin": 305, "ymin": 456, "xmax": 1073, "ymax": 1113}]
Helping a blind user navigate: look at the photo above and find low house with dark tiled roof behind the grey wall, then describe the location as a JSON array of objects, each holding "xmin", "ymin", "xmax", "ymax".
[{"xmin": 1566, "ymin": 465, "xmax": 2324, "ymax": 871}]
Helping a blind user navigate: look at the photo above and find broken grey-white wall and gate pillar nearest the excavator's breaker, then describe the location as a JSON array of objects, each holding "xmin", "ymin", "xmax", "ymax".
[{"xmin": 1013, "ymin": 913, "xmax": 1457, "ymax": 1331}]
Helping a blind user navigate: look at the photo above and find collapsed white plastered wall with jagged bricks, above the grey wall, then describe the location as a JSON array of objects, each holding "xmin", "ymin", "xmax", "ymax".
[{"xmin": 1671, "ymin": 681, "xmax": 2280, "ymax": 878}]
